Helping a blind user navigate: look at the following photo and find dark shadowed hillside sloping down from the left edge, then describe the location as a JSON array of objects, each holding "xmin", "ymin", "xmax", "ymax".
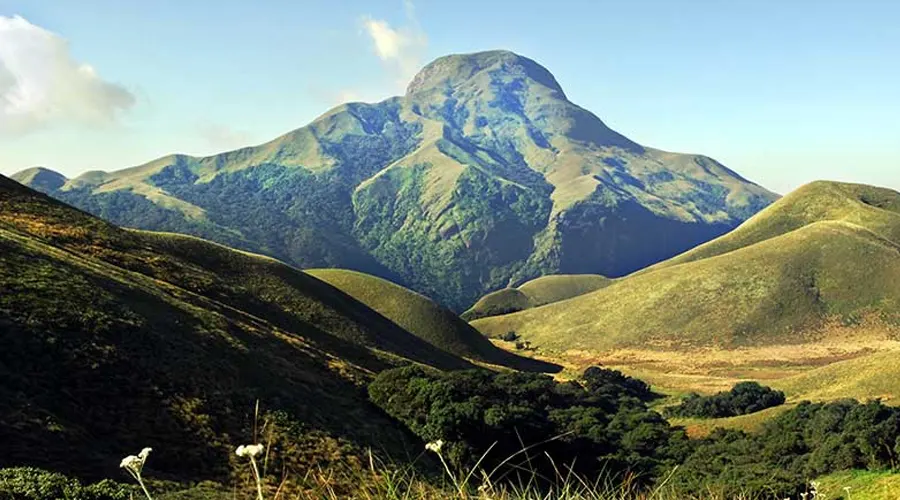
[{"xmin": 0, "ymin": 176, "xmax": 486, "ymax": 480}]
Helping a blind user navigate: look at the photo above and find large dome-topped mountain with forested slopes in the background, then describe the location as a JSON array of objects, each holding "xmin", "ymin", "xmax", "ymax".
[{"xmin": 15, "ymin": 51, "xmax": 777, "ymax": 311}]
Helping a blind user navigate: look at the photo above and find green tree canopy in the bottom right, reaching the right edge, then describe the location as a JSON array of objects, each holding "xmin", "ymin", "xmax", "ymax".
[{"xmin": 670, "ymin": 400, "xmax": 900, "ymax": 498}]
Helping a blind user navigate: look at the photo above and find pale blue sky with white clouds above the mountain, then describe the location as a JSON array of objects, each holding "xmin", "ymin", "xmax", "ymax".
[{"xmin": 0, "ymin": 0, "xmax": 900, "ymax": 193}]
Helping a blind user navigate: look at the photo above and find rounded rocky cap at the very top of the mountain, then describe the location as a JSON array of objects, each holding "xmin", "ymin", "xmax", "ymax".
[{"xmin": 406, "ymin": 50, "xmax": 565, "ymax": 98}]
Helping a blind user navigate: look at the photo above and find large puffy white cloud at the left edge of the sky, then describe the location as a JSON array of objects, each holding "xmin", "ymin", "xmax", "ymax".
[{"xmin": 0, "ymin": 16, "xmax": 135, "ymax": 136}]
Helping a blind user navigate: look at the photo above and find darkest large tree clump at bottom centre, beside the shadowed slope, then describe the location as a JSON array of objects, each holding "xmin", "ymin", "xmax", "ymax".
[{"xmin": 369, "ymin": 367, "xmax": 687, "ymax": 486}]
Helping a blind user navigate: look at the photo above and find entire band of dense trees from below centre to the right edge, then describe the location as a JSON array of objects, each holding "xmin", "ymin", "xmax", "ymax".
[{"xmin": 369, "ymin": 367, "xmax": 900, "ymax": 498}]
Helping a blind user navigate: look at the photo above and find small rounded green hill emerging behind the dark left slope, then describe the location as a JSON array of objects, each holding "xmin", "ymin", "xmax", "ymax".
[{"xmin": 306, "ymin": 269, "xmax": 559, "ymax": 372}]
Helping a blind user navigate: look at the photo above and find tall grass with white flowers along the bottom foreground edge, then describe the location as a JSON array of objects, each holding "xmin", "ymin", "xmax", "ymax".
[{"xmin": 109, "ymin": 441, "xmax": 804, "ymax": 500}]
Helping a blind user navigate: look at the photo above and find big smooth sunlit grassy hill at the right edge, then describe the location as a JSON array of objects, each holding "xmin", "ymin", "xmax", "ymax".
[{"xmin": 473, "ymin": 182, "xmax": 900, "ymax": 350}]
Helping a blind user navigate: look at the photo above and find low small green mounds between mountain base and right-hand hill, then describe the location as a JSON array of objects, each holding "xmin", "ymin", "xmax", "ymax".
[{"xmin": 462, "ymin": 274, "xmax": 613, "ymax": 321}]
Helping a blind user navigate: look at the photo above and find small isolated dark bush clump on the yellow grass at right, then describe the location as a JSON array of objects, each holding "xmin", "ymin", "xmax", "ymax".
[{"xmin": 666, "ymin": 382, "xmax": 784, "ymax": 418}]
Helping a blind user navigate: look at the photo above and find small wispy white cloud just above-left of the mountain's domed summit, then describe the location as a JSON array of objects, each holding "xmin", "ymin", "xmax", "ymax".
[{"xmin": 363, "ymin": 0, "xmax": 428, "ymax": 89}]
